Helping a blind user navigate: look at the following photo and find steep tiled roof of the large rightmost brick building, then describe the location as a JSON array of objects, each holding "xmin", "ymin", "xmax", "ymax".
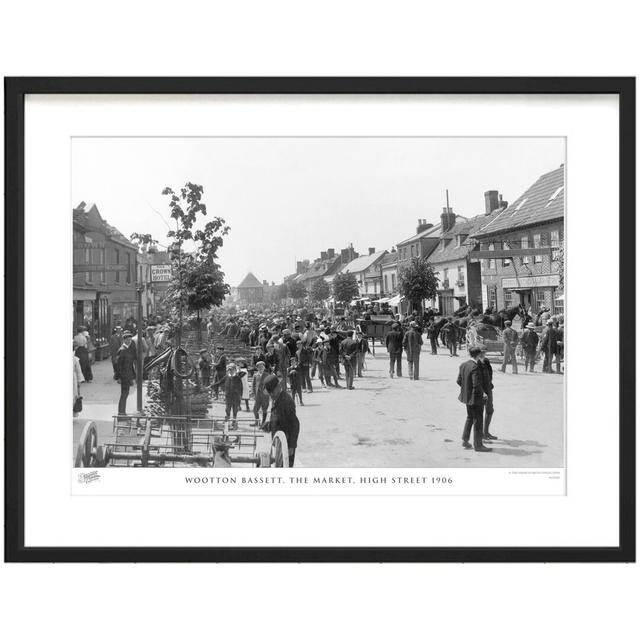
[{"xmin": 475, "ymin": 165, "xmax": 564, "ymax": 237}]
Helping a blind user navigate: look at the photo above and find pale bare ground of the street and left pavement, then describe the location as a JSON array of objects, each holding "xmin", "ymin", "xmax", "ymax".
[{"xmin": 74, "ymin": 347, "xmax": 564, "ymax": 468}]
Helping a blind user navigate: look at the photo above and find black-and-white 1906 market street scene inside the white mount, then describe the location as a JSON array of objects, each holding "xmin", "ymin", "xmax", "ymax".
[{"xmin": 68, "ymin": 136, "xmax": 572, "ymax": 476}]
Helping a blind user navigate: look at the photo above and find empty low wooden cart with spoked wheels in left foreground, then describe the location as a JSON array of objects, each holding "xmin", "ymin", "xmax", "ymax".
[{"xmin": 74, "ymin": 416, "xmax": 289, "ymax": 467}]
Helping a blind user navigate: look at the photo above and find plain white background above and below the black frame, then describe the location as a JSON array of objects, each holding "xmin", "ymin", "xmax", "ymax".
[{"xmin": 0, "ymin": 1, "xmax": 638, "ymax": 638}]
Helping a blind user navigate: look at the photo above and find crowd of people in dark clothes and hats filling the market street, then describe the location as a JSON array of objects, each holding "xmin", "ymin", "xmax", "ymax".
[{"xmin": 73, "ymin": 300, "xmax": 564, "ymax": 464}]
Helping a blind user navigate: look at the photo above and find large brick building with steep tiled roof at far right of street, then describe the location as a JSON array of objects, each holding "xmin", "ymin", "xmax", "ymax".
[{"xmin": 470, "ymin": 165, "xmax": 564, "ymax": 314}]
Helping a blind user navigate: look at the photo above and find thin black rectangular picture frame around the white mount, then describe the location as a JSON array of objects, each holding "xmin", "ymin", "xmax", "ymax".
[{"xmin": 4, "ymin": 77, "xmax": 636, "ymax": 562}]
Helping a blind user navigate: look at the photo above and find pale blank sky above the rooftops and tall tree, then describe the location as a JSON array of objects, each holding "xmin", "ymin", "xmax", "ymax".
[{"xmin": 71, "ymin": 137, "xmax": 565, "ymax": 286}]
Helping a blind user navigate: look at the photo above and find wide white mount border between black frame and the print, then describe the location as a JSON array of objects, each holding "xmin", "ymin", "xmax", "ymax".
[{"xmin": 25, "ymin": 96, "xmax": 618, "ymax": 546}]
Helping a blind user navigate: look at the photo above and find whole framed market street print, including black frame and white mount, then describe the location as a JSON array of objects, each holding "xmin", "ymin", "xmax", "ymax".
[{"xmin": 5, "ymin": 78, "xmax": 635, "ymax": 562}]
